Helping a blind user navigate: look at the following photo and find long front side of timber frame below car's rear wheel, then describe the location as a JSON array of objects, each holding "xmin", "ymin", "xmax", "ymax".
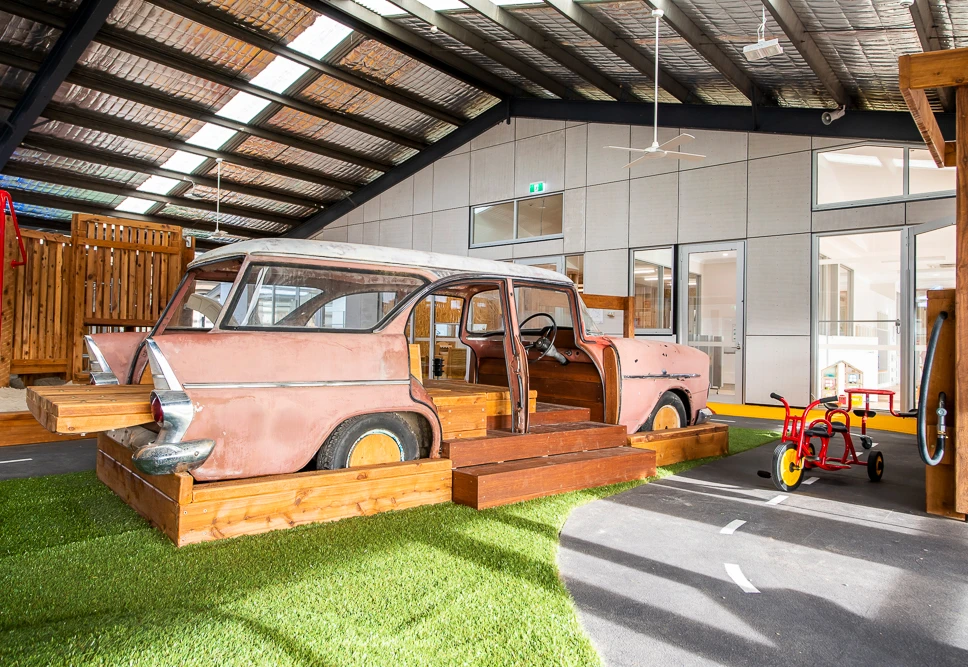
[{"xmin": 176, "ymin": 460, "xmax": 452, "ymax": 546}]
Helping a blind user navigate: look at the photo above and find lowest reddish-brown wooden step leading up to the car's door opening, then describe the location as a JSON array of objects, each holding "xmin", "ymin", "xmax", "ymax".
[{"xmin": 453, "ymin": 447, "xmax": 655, "ymax": 509}]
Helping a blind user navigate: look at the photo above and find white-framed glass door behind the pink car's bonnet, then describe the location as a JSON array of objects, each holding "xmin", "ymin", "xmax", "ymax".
[{"xmin": 678, "ymin": 241, "xmax": 746, "ymax": 403}]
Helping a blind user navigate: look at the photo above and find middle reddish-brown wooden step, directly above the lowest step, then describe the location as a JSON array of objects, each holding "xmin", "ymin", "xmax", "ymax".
[{"xmin": 440, "ymin": 422, "xmax": 628, "ymax": 468}]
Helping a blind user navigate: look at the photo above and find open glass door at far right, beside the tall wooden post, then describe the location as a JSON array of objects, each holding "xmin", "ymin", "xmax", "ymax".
[{"xmin": 906, "ymin": 219, "xmax": 957, "ymax": 407}]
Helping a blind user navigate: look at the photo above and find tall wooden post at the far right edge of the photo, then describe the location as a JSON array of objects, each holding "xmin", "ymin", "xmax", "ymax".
[{"xmin": 955, "ymin": 86, "xmax": 968, "ymax": 514}]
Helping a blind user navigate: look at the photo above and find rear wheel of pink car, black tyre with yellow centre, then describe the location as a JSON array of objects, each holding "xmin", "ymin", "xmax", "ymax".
[{"xmin": 316, "ymin": 412, "xmax": 420, "ymax": 470}]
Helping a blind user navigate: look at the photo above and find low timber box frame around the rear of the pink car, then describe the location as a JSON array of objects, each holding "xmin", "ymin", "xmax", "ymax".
[{"xmin": 97, "ymin": 433, "xmax": 451, "ymax": 546}]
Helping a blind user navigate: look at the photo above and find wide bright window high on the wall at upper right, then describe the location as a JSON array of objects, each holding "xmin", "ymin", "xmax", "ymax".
[{"xmin": 814, "ymin": 145, "xmax": 955, "ymax": 207}]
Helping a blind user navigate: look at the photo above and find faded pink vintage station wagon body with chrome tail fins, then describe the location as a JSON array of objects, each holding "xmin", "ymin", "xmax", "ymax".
[{"xmin": 88, "ymin": 239, "xmax": 709, "ymax": 481}]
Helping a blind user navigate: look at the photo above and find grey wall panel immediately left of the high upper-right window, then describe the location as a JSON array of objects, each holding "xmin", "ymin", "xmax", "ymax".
[{"xmin": 747, "ymin": 151, "xmax": 811, "ymax": 236}]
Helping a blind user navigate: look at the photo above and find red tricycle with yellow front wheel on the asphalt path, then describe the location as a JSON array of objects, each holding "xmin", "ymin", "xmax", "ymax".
[{"xmin": 761, "ymin": 389, "xmax": 910, "ymax": 492}]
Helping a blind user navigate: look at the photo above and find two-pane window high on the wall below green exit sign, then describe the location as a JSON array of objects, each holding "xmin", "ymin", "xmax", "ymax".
[{"xmin": 471, "ymin": 194, "xmax": 562, "ymax": 246}]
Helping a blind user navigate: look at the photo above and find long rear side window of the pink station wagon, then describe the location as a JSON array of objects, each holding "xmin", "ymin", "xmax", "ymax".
[{"xmin": 223, "ymin": 264, "xmax": 427, "ymax": 331}]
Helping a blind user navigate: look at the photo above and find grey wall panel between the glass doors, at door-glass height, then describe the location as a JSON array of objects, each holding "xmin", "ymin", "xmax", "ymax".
[{"xmin": 746, "ymin": 234, "xmax": 810, "ymax": 340}]
